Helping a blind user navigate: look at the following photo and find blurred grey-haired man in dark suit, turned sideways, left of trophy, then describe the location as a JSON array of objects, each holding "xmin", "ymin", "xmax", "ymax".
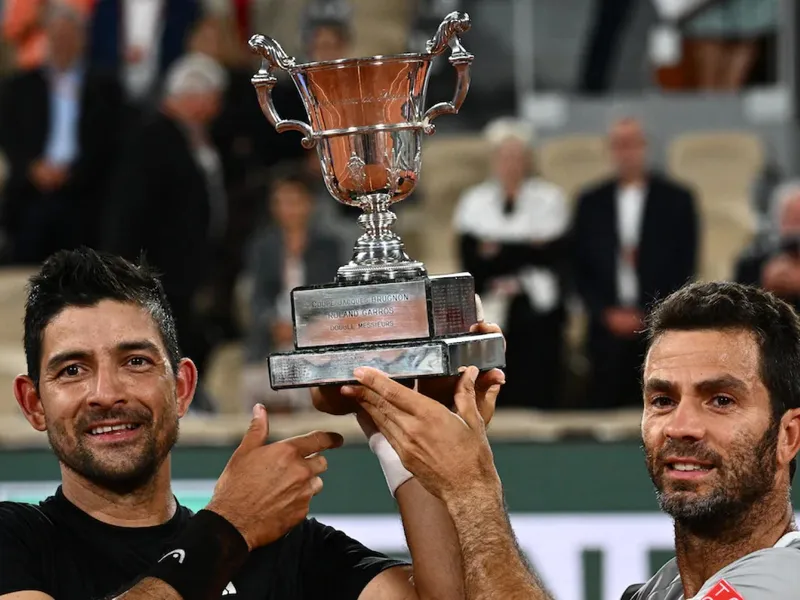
[{"xmin": 104, "ymin": 54, "xmax": 227, "ymax": 412}]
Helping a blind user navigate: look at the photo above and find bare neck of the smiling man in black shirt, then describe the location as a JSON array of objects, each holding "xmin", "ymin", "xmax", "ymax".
[{"xmin": 61, "ymin": 459, "xmax": 177, "ymax": 527}]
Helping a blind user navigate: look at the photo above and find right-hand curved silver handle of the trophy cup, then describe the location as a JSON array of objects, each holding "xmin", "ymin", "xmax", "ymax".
[{"xmin": 422, "ymin": 11, "xmax": 475, "ymax": 135}]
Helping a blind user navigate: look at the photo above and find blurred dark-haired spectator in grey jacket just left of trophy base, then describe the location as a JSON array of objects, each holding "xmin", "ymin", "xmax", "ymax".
[{"xmin": 242, "ymin": 167, "xmax": 341, "ymax": 412}]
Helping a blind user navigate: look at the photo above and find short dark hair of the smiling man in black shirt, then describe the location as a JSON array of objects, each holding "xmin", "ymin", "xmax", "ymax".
[{"xmin": 24, "ymin": 248, "xmax": 180, "ymax": 387}]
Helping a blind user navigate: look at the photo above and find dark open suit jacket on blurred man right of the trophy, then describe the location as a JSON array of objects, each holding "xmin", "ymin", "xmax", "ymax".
[{"xmin": 571, "ymin": 175, "xmax": 698, "ymax": 319}]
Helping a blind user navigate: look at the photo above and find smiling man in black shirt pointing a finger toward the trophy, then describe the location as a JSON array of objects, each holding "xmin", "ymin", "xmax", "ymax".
[{"xmin": 0, "ymin": 250, "xmax": 468, "ymax": 600}]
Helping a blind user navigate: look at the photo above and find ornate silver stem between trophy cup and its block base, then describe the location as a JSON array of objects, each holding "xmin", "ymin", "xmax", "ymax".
[{"xmin": 336, "ymin": 194, "xmax": 426, "ymax": 283}]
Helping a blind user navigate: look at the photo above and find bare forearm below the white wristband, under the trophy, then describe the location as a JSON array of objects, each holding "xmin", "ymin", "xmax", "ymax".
[{"xmin": 396, "ymin": 479, "xmax": 464, "ymax": 600}]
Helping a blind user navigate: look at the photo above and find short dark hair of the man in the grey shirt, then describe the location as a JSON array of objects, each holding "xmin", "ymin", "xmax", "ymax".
[{"xmin": 646, "ymin": 282, "xmax": 800, "ymax": 478}]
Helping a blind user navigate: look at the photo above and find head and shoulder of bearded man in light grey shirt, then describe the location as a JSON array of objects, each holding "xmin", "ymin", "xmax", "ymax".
[{"xmin": 633, "ymin": 283, "xmax": 800, "ymax": 600}]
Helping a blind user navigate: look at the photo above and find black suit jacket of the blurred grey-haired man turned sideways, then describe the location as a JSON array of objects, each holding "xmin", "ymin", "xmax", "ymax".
[{"xmin": 103, "ymin": 113, "xmax": 213, "ymax": 302}]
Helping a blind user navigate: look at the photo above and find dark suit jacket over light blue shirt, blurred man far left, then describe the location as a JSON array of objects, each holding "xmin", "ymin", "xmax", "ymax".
[{"xmin": 0, "ymin": 69, "xmax": 123, "ymax": 230}]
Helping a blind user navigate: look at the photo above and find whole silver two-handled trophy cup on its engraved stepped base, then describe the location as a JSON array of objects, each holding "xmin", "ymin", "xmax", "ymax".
[{"xmin": 250, "ymin": 12, "xmax": 505, "ymax": 389}]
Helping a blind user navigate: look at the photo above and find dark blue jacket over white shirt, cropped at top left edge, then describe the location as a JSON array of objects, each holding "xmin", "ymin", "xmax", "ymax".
[{"xmin": 89, "ymin": 0, "xmax": 201, "ymax": 85}]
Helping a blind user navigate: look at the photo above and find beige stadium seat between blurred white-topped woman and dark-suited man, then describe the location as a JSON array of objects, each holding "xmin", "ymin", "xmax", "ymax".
[{"xmin": 537, "ymin": 135, "xmax": 612, "ymax": 201}]
